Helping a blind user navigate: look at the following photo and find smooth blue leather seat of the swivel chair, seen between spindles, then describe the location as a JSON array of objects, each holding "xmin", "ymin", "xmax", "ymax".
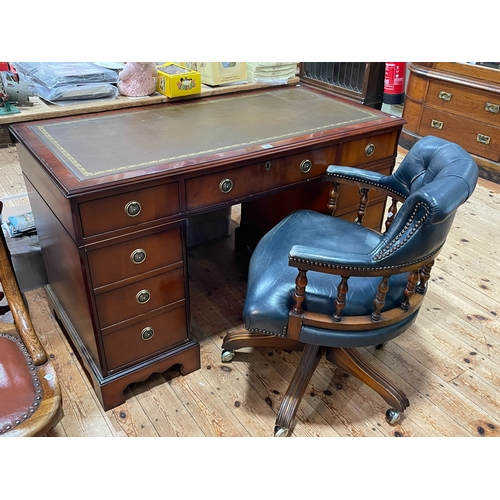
[{"xmin": 243, "ymin": 210, "xmax": 408, "ymax": 346}]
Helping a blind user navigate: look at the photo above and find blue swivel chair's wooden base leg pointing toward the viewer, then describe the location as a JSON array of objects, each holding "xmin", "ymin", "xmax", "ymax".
[{"xmin": 274, "ymin": 344, "xmax": 323, "ymax": 437}]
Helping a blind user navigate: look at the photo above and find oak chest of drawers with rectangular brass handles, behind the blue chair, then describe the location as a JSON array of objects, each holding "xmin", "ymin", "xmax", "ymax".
[{"xmin": 400, "ymin": 63, "xmax": 500, "ymax": 182}]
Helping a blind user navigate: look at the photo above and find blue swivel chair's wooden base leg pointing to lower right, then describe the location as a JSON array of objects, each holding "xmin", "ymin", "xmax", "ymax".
[{"xmin": 326, "ymin": 347, "xmax": 410, "ymax": 413}]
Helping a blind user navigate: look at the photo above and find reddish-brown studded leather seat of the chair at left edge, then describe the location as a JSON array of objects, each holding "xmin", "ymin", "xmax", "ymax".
[{"xmin": 0, "ymin": 334, "xmax": 40, "ymax": 435}]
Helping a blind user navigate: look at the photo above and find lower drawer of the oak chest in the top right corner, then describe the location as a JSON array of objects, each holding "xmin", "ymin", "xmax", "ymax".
[{"xmin": 418, "ymin": 108, "xmax": 500, "ymax": 161}]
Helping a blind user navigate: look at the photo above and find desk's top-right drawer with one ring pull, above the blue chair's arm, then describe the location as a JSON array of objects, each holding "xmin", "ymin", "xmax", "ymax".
[{"xmin": 338, "ymin": 131, "xmax": 398, "ymax": 167}]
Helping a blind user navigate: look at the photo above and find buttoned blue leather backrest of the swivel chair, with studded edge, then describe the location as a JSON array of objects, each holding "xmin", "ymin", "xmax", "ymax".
[{"xmin": 374, "ymin": 136, "xmax": 478, "ymax": 266}]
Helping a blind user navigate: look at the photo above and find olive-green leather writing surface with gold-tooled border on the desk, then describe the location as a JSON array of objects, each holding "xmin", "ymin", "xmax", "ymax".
[{"xmin": 29, "ymin": 87, "xmax": 380, "ymax": 181}]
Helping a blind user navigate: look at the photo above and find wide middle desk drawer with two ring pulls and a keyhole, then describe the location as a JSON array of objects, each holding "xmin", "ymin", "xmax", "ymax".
[{"xmin": 186, "ymin": 146, "xmax": 336, "ymax": 210}]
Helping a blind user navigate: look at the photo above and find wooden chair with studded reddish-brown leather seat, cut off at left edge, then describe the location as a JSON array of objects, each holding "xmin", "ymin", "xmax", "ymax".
[{"xmin": 0, "ymin": 202, "xmax": 63, "ymax": 437}]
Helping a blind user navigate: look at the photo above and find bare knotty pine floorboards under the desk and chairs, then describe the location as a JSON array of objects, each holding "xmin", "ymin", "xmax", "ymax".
[{"xmin": 0, "ymin": 148, "xmax": 500, "ymax": 437}]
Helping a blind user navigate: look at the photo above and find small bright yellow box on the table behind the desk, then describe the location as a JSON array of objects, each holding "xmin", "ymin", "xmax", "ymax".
[{"xmin": 156, "ymin": 63, "xmax": 201, "ymax": 97}]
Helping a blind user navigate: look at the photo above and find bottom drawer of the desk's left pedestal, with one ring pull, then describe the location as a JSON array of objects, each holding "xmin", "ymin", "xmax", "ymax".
[{"xmin": 102, "ymin": 302, "xmax": 187, "ymax": 371}]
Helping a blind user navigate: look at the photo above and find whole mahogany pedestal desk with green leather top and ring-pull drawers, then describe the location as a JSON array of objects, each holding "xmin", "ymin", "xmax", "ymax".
[{"xmin": 10, "ymin": 87, "xmax": 404, "ymax": 409}]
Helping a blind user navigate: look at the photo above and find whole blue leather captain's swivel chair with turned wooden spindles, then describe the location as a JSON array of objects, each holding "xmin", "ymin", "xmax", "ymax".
[{"xmin": 222, "ymin": 136, "xmax": 478, "ymax": 436}]
